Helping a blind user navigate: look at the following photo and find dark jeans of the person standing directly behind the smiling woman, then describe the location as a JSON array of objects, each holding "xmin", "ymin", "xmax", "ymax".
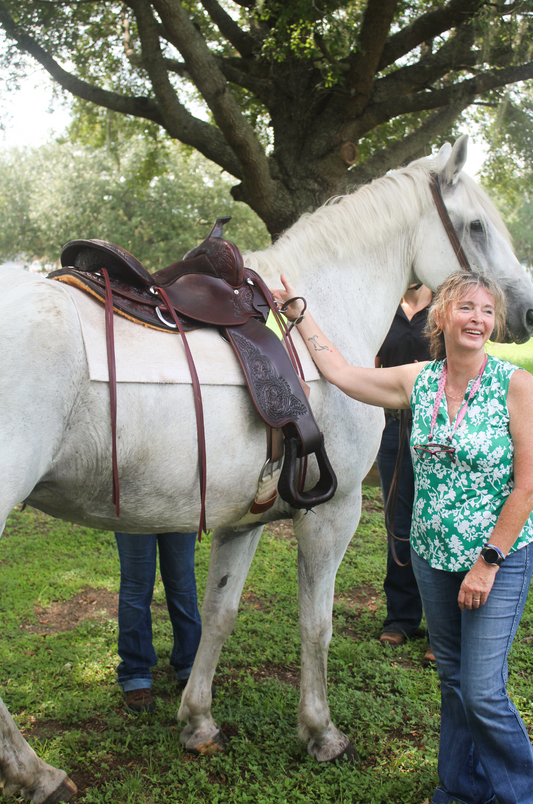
[{"xmin": 377, "ymin": 419, "xmax": 422, "ymax": 637}]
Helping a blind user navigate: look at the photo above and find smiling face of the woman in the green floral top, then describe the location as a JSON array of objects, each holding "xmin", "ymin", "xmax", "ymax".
[{"xmin": 441, "ymin": 288, "xmax": 495, "ymax": 351}]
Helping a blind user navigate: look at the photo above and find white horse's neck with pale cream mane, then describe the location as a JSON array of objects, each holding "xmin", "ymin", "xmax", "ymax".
[{"xmin": 246, "ymin": 164, "xmax": 432, "ymax": 362}]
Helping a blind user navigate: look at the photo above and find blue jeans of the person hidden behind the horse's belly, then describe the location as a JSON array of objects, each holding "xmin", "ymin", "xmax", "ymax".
[{"xmin": 115, "ymin": 533, "xmax": 202, "ymax": 692}]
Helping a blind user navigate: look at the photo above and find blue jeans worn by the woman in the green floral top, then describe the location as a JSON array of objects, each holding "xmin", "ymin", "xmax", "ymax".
[{"xmin": 412, "ymin": 544, "xmax": 533, "ymax": 804}]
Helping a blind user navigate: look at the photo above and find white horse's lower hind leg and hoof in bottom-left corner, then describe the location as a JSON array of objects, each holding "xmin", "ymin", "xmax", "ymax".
[{"xmin": 0, "ymin": 698, "xmax": 77, "ymax": 804}]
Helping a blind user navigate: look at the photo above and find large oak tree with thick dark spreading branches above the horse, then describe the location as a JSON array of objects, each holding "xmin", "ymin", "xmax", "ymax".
[{"xmin": 0, "ymin": 0, "xmax": 533, "ymax": 235}]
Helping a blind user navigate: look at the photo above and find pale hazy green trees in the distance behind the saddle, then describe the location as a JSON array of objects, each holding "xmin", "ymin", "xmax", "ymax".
[{"xmin": 0, "ymin": 137, "xmax": 269, "ymax": 270}]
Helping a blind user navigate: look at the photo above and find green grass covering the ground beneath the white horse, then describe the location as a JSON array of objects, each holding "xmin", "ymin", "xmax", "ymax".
[{"xmin": 0, "ymin": 346, "xmax": 533, "ymax": 804}]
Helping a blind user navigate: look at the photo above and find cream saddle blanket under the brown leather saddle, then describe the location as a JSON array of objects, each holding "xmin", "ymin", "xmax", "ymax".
[{"xmin": 61, "ymin": 284, "xmax": 320, "ymax": 385}]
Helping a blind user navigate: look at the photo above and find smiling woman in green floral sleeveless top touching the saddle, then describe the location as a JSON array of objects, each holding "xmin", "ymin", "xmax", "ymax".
[{"xmin": 275, "ymin": 272, "xmax": 533, "ymax": 804}]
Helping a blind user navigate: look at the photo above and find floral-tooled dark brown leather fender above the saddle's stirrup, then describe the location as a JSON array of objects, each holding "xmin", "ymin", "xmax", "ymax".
[{"xmin": 233, "ymin": 333, "xmax": 308, "ymax": 425}]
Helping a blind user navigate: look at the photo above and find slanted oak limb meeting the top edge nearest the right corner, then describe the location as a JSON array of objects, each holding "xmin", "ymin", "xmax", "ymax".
[{"xmin": 377, "ymin": 0, "xmax": 487, "ymax": 72}]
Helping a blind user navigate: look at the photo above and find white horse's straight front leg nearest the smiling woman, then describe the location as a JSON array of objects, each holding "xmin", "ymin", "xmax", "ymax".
[{"xmin": 295, "ymin": 506, "xmax": 361, "ymax": 762}]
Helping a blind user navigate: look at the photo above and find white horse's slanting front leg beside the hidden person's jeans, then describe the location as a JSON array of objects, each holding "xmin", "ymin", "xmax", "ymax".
[{"xmin": 178, "ymin": 525, "xmax": 263, "ymax": 754}]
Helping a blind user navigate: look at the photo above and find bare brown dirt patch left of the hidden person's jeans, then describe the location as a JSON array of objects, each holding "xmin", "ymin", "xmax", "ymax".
[{"xmin": 19, "ymin": 586, "xmax": 118, "ymax": 634}]
